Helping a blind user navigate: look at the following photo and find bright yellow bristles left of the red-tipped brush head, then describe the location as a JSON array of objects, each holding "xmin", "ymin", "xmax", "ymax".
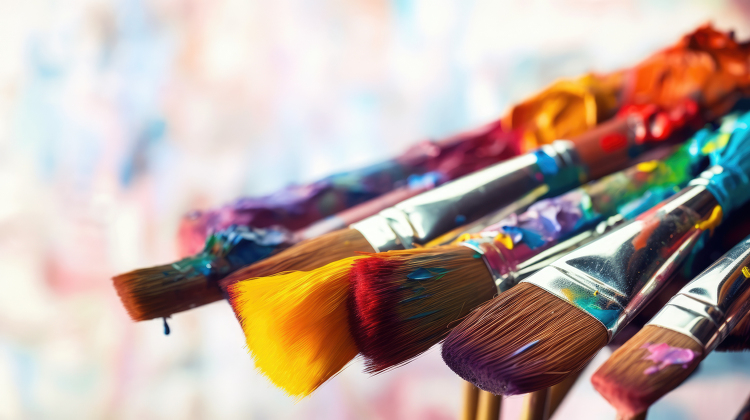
[{"xmin": 227, "ymin": 257, "xmax": 362, "ymax": 398}]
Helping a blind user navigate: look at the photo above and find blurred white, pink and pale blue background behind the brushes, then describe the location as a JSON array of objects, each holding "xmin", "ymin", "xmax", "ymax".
[{"xmin": 0, "ymin": 0, "xmax": 750, "ymax": 419}]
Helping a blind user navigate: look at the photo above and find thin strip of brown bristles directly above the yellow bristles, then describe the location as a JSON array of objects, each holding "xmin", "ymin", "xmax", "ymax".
[{"xmin": 219, "ymin": 228, "xmax": 375, "ymax": 290}]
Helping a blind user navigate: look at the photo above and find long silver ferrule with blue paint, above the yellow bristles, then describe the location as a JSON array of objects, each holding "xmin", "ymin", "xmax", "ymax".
[{"xmin": 351, "ymin": 140, "xmax": 585, "ymax": 252}]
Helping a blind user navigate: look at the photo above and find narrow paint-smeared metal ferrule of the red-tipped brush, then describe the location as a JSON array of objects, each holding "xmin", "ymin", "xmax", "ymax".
[{"xmin": 459, "ymin": 214, "xmax": 625, "ymax": 293}]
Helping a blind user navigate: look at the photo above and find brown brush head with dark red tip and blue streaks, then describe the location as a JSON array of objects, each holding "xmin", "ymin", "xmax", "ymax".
[{"xmin": 349, "ymin": 246, "xmax": 497, "ymax": 373}]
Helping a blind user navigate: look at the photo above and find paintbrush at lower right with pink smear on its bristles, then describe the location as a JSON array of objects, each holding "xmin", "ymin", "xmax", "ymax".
[{"xmin": 591, "ymin": 237, "xmax": 750, "ymax": 416}]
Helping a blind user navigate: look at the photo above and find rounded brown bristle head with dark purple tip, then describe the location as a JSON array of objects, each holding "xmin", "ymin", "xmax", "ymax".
[{"xmin": 443, "ymin": 283, "xmax": 607, "ymax": 395}]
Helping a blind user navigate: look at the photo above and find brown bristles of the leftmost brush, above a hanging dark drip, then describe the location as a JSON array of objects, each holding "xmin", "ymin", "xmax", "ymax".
[{"xmin": 112, "ymin": 260, "xmax": 222, "ymax": 321}]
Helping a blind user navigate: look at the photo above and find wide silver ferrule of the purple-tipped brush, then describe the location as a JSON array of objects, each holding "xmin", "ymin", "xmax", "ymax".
[{"xmin": 524, "ymin": 172, "xmax": 718, "ymax": 339}]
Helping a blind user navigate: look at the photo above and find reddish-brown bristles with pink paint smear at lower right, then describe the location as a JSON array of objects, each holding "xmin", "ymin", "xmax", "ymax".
[{"xmin": 591, "ymin": 325, "xmax": 704, "ymax": 416}]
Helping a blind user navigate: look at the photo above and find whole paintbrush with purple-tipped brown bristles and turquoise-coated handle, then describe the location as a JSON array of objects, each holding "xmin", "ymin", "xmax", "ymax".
[{"xmin": 442, "ymin": 109, "xmax": 750, "ymax": 395}]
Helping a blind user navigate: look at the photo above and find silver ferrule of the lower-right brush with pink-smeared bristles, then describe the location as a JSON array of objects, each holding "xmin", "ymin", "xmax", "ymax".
[{"xmin": 647, "ymin": 237, "xmax": 750, "ymax": 354}]
